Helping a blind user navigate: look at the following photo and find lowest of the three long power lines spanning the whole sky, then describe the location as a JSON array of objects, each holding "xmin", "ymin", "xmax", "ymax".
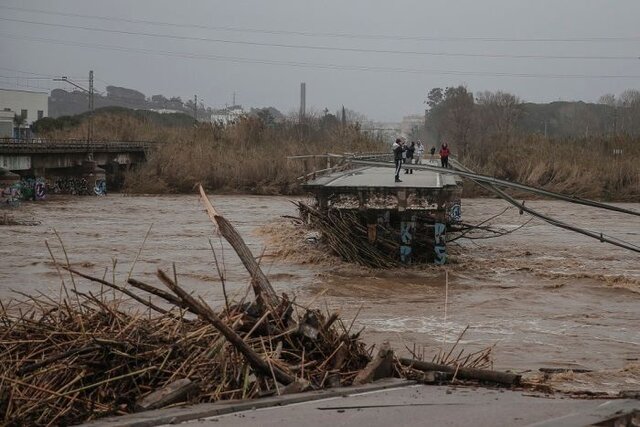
[{"xmin": 5, "ymin": 32, "xmax": 640, "ymax": 79}]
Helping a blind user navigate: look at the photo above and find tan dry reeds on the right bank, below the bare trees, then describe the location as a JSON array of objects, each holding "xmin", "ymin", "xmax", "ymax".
[{"xmin": 463, "ymin": 135, "xmax": 640, "ymax": 202}]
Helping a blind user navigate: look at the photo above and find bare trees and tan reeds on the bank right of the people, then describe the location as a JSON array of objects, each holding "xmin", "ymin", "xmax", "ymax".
[{"xmin": 418, "ymin": 86, "xmax": 640, "ymax": 201}]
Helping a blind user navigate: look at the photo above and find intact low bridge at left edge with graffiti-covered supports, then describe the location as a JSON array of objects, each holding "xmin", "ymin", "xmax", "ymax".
[{"xmin": 0, "ymin": 138, "xmax": 157, "ymax": 200}]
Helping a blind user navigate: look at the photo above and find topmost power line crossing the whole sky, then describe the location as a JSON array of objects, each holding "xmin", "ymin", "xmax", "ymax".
[{"xmin": 0, "ymin": 5, "xmax": 640, "ymax": 43}]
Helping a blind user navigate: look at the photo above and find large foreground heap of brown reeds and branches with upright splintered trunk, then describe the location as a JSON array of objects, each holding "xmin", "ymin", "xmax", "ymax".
[{"xmin": 0, "ymin": 188, "xmax": 370, "ymax": 426}]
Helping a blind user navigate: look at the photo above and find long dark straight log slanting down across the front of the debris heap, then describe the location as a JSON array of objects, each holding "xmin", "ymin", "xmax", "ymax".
[{"xmin": 158, "ymin": 270, "xmax": 295, "ymax": 385}]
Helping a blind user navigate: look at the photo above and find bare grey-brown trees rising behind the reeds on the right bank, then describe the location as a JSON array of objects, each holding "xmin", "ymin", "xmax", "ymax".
[{"xmin": 411, "ymin": 86, "xmax": 640, "ymax": 155}]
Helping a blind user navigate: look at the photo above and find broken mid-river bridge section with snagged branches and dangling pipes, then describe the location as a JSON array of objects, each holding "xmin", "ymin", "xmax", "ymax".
[{"xmin": 293, "ymin": 154, "xmax": 640, "ymax": 268}]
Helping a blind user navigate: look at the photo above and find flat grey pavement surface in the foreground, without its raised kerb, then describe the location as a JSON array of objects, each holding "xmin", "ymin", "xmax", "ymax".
[{"xmin": 178, "ymin": 386, "xmax": 640, "ymax": 427}]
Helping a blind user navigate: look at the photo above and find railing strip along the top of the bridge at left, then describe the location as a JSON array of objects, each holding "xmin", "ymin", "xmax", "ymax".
[{"xmin": 0, "ymin": 138, "xmax": 161, "ymax": 154}]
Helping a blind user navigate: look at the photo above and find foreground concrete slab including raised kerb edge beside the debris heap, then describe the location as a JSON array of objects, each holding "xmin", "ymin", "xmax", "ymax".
[{"xmin": 85, "ymin": 381, "xmax": 640, "ymax": 427}]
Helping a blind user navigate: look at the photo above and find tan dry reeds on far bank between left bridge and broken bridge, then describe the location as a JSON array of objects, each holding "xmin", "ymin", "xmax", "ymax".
[{"xmin": 47, "ymin": 114, "xmax": 384, "ymax": 194}]
